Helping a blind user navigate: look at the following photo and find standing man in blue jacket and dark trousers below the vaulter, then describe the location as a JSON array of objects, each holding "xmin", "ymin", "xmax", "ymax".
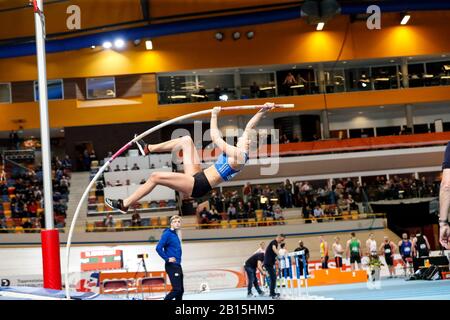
[{"xmin": 156, "ymin": 215, "xmax": 184, "ymax": 300}]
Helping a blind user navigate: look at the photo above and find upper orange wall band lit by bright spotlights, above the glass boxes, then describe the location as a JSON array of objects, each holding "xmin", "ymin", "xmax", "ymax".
[{"xmin": 0, "ymin": 12, "xmax": 450, "ymax": 82}]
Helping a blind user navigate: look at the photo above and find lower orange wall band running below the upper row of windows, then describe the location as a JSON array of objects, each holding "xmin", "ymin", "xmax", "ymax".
[{"xmin": 0, "ymin": 87, "xmax": 450, "ymax": 130}]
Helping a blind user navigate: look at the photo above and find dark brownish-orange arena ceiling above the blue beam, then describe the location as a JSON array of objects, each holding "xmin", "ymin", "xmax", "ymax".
[{"xmin": 0, "ymin": 0, "xmax": 436, "ymax": 44}]
